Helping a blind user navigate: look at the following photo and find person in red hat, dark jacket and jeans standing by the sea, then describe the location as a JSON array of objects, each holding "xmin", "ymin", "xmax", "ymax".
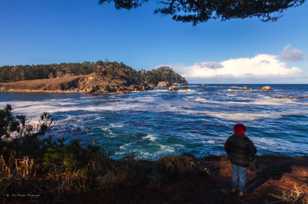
[{"xmin": 225, "ymin": 124, "xmax": 257, "ymax": 196}]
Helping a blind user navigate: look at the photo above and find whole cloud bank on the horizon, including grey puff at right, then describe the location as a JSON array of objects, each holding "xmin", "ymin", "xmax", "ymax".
[{"xmin": 175, "ymin": 49, "xmax": 308, "ymax": 83}]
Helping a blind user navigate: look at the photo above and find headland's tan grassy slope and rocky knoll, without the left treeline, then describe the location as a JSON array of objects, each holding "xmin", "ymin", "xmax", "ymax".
[{"xmin": 0, "ymin": 62, "xmax": 187, "ymax": 94}]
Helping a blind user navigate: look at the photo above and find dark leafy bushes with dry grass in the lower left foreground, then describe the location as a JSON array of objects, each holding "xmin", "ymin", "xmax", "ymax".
[{"xmin": 0, "ymin": 105, "xmax": 114, "ymax": 193}]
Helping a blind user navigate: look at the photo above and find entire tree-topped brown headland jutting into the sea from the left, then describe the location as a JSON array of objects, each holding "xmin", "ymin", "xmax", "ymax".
[{"xmin": 0, "ymin": 61, "xmax": 187, "ymax": 94}]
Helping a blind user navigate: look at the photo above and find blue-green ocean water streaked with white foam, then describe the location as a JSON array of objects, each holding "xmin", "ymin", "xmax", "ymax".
[{"xmin": 0, "ymin": 84, "xmax": 308, "ymax": 159}]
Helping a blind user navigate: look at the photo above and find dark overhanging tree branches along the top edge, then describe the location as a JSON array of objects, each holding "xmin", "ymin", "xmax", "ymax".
[{"xmin": 99, "ymin": 0, "xmax": 305, "ymax": 25}]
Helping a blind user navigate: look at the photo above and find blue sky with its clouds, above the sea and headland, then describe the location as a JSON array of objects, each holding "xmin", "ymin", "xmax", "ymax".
[{"xmin": 0, "ymin": 0, "xmax": 308, "ymax": 83}]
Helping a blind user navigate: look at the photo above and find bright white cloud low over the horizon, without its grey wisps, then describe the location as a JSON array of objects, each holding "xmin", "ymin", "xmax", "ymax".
[{"xmin": 177, "ymin": 54, "xmax": 302, "ymax": 83}]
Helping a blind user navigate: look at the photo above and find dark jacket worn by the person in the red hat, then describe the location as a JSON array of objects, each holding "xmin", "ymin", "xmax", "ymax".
[{"xmin": 225, "ymin": 135, "xmax": 257, "ymax": 167}]
